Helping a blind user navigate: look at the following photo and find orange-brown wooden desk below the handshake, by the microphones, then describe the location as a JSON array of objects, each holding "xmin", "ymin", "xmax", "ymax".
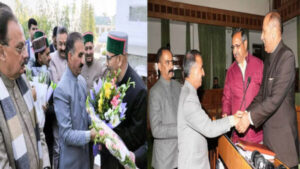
[{"xmin": 217, "ymin": 135, "xmax": 288, "ymax": 169}]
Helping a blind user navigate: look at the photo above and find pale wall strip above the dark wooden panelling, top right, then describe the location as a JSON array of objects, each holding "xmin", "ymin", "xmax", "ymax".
[{"xmin": 170, "ymin": 0, "xmax": 269, "ymax": 15}]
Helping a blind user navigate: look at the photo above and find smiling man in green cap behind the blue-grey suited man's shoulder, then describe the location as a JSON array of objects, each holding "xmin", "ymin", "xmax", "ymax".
[{"xmin": 81, "ymin": 32, "xmax": 106, "ymax": 93}]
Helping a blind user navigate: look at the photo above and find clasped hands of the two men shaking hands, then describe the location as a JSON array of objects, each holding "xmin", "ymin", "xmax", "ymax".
[{"xmin": 225, "ymin": 110, "xmax": 250, "ymax": 133}]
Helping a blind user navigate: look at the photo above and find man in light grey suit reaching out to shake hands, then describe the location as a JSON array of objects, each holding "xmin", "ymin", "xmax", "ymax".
[{"xmin": 177, "ymin": 50, "xmax": 240, "ymax": 169}]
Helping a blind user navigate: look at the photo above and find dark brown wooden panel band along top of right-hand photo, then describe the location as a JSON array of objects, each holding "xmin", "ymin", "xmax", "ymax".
[{"xmin": 148, "ymin": 0, "xmax": 264, "ymax": 30}]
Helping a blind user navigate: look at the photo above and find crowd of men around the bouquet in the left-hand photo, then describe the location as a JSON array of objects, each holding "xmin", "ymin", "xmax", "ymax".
[{"xmin": 0, "ymin": 3, "xmax": 147, "ymax": 169}]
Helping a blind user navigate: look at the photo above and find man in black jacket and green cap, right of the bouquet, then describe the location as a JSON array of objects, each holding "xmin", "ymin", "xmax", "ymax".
[{"xmin": 101, "ymin": 31, "xmax": 147, "ymax": 169}]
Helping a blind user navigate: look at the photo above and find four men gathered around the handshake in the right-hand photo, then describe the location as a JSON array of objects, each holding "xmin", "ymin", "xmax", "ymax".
[{"xmin": 148, "ymin": 12, "xmax": 299, "ymax": 169}]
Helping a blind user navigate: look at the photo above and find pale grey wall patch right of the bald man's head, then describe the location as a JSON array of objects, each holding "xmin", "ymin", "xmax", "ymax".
[{"xmin": 282, "ymin": 17, "xmax": 300, "ymax": 67}]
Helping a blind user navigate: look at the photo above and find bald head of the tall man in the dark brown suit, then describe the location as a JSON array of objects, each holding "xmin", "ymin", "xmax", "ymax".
[{"xmin": 261, "ymin": 12, "xmax": 282, "ymax": 53}]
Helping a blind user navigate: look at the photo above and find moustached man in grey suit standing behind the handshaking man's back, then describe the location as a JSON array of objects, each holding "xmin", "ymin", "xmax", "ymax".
[{"xmin": 149, "ymin": 47, "xmax": 181, "ymax": 169}]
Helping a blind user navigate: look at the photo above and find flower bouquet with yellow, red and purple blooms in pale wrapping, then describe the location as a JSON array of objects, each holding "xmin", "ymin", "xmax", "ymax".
[{"xmin": 86, "ymin": 70, "xmax": 137, "ymax": 169}]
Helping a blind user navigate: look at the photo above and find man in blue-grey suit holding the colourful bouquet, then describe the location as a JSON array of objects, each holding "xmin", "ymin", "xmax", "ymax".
[{"xmin": 54, "ymin": 32, "xmax": 96, "ymax": 169}]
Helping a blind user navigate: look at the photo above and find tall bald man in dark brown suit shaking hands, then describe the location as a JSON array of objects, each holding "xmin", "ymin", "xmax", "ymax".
[{"xmin": 237, "ymin": 12, "xmax": 299, "ymax": 168}]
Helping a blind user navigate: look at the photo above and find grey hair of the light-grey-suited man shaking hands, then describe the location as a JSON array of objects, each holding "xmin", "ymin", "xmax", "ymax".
[{"xmin": 183, "ymin": 49, "xmax": 201, "ymax": 77}]
